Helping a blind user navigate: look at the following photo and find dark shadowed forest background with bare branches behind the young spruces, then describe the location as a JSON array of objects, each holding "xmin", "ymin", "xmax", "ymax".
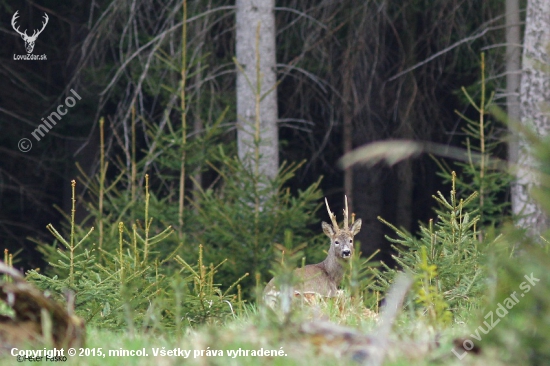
[{"xmin": 0, "ymin": 0, "xmax": 507, "ymax": 269}]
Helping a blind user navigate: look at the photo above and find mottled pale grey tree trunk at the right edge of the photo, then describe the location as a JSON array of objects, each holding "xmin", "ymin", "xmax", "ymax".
[{"xmin": 512, "ymin": 0, "xmax": 550, "ymax": 235}]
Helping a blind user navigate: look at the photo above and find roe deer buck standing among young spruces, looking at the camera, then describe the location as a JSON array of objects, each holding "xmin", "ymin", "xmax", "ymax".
[{"xmin": 264, "ymin": 197, "xmax": 361, "ymax": 306}]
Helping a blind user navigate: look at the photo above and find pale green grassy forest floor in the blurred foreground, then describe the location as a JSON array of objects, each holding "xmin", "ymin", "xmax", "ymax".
[{"xmin": 0, "ymin": 298, "xmax": 508, "ymax": 366}]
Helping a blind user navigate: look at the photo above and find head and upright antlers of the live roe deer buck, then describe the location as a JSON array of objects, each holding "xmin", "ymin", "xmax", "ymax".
[{"xmin": 321, "ymin": 197, "xmax": 362, "ymax": 261}]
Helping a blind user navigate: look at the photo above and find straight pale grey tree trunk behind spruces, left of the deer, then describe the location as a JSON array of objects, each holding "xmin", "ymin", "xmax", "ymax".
[{"xmin": 236, "ymin": 0, "xmax": 279, "ymax": 178}]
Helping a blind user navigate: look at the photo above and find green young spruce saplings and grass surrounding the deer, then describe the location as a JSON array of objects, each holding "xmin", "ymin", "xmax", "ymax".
[{"xmin": 0, "ymin": 57, "xmax": 550, "ymax": 365}]
